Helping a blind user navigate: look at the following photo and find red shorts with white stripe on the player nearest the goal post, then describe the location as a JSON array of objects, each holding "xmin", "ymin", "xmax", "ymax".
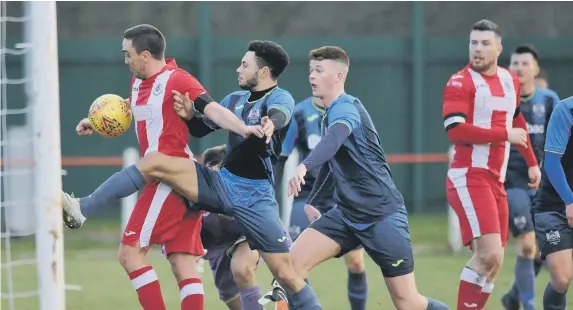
[{"xmin": 121, "ymin": 182, "xmax": 204, "ymax": 256}]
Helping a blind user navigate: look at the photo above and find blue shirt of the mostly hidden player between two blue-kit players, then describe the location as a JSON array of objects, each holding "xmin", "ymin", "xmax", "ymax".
[{"xmin": 281, "ymin": 97, "xmax": 324, "ymax": 197}]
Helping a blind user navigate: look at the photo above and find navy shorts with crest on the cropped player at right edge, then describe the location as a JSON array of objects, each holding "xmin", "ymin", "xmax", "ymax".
[{"xmin": 533, "ymin": 211, "xmax": 573, "ymax": 259}]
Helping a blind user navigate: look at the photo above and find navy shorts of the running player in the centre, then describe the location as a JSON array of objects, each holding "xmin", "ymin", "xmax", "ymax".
[{"xmin": 310, "ymin": 206, "xmax": 414, "ymax": 278}]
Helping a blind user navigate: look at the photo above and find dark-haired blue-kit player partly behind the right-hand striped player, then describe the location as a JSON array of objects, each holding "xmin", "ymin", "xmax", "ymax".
[{"xmin": 502, "ymin": 45, "xmax": 559, "ymax": 310}]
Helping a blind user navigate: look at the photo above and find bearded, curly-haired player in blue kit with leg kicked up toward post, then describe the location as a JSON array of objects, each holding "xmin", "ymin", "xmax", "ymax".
[{"xmin": 65, "ymin": 41, "xmax": 322, "ymax": 310}]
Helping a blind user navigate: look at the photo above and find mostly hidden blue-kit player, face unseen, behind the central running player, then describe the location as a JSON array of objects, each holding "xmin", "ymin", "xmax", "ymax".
[{"xmin": 276, "ymin": 97, "xmax": 368, "ymax": 310}]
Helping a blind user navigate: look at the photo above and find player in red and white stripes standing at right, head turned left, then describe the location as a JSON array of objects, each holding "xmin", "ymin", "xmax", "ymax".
[{"xmin": 443, "ymin": 20, "xmax": 541, "ymax": 310}]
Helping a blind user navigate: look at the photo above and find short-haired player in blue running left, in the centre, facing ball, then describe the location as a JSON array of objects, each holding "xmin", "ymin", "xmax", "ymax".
[{"xmin": 289, "ymin": 46, "xmax": 449, "ymax": 310}]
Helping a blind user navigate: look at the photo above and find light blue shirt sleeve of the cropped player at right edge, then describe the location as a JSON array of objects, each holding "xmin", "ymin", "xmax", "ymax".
[{"xmin": 545, "ymin": 101, "xmax": 573, "ymax": 154}]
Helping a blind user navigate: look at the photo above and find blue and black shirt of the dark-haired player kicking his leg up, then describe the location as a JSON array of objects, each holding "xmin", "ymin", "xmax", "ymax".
[{"xmin": 203, "ymin": 87, "xmax": 294, "ymax": 181}]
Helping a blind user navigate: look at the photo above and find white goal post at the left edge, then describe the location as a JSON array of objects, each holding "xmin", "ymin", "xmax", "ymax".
[{"xmin": 25, "ymin": 1, "xmax": 66, "ymax": 310}]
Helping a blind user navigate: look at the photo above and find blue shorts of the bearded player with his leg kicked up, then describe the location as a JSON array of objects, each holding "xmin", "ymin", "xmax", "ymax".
[{"xmin": 190, "ymin": 162, "xmax": 290, "ymax": 253}]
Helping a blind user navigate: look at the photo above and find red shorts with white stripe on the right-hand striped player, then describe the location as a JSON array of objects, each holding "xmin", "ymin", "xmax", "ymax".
[{"xmin": 446, "ymin": 168, "xmax": 509, "ymax": 247}]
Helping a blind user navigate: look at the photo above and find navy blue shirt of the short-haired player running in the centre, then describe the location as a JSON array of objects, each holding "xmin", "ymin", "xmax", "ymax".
[{"xmin": 321, "ymin": 93, "xmax": 404, "ymax": 223}]
